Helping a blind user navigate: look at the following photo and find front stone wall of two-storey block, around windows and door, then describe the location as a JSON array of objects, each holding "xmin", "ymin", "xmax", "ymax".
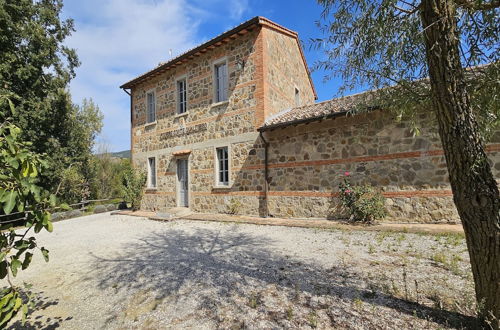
[{"xmin": 132, "ymin": 29, "xmax": 263, "ymax": 214}]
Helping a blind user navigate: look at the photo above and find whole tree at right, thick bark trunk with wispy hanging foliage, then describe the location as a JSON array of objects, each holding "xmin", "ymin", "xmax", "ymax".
[{"xmin": 314, "ymin": 0, "xmax": 500, "ymax": 328}]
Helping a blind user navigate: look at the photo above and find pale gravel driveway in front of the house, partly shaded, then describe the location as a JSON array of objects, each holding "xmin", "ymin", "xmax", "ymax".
[{"xmin": 3, "ymin": 213, "xmax": 474, "ymax": 329}]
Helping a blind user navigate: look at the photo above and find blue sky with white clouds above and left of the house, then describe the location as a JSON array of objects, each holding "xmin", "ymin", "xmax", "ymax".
[{"xmin": 63, "ymin": 0, "xmax": 340, "ymax": 151}]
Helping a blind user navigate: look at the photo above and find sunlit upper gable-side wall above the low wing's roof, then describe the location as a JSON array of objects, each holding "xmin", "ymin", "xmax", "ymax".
[{"xmin": 263, "ymin": 27, "xmax": 315, "ymax": 118}]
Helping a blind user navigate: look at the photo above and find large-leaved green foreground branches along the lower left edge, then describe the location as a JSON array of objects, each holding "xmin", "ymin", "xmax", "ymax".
[{"xmin": 0, "ymin": 94, "xmax": 56, "ymax": 327}]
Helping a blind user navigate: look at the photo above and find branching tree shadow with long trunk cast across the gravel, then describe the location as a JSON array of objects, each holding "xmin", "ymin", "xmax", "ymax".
[{"xmin": 89, "ymin": 225, "xmax": 477, "ymax": 328}]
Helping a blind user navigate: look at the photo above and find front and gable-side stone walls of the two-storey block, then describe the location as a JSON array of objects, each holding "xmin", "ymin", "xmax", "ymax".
[{"xmin": 124, "ymin": 18, "xmax": 315, "ymax": 219}]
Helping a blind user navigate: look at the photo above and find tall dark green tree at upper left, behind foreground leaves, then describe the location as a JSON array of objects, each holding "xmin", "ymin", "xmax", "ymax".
[{"xmin": 0, "ymin": 0, "xmax": 103, "ymax": 198}]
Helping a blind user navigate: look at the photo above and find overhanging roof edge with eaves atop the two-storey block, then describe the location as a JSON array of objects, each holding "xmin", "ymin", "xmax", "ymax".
[{"xmin": 120, "ymin": 16, "xmax": 318, "ymax": 98}]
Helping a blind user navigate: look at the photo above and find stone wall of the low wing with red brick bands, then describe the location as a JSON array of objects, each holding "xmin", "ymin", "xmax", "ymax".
[{"xmin": 266, "ymin": 111, "xmax": 500, "ymax": 222}]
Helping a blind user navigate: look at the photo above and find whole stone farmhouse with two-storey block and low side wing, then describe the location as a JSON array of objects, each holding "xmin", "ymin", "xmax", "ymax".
[{"xmin": 121, "ymin": 17, "xmax": 500, "ymax": 222}]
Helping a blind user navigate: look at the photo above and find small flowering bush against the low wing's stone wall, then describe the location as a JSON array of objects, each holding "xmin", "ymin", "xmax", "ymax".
[{"xmin": 339, "ymin": 172, "xmax": 387, "ymax": 223}]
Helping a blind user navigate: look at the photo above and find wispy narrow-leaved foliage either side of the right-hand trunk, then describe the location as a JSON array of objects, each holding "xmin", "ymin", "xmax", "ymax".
[{"xmin": 312, "ymin": 0, "xmax": 500, "ymax": 140}]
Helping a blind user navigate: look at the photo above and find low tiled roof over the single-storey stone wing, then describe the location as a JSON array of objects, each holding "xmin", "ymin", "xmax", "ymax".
[{"xmin": 259, "ymin": 92, "xmax": 371, "ymax": 131}]
